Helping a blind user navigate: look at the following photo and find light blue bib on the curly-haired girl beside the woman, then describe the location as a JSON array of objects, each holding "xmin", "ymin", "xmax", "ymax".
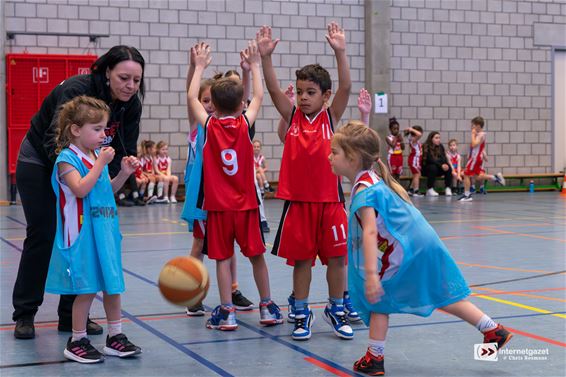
[{"xmin": 45, "ymin": 149, "xmax": 125, "ymax": 294}]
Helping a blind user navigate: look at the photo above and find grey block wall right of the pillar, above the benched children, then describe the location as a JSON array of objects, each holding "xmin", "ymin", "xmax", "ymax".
[{"xmin": 391, "ymin": 0, "xmax": 566, "ymax": 174}]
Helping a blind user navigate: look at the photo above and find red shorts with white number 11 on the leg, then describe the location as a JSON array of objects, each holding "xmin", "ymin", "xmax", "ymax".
[{"xmin": 272, "ymin": 201, "xmax": 348, "ymax": 265}]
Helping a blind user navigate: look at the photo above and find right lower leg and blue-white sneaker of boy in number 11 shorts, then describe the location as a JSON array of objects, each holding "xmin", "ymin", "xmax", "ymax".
[{"xmin": 324, "ymin": 257, "xmax": 354, "ymax": 339}]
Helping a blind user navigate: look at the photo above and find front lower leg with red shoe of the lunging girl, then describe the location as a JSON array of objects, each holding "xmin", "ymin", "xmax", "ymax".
[{"xmin": 354, "ymin": 313, "xmax": 389, "ymax": 376}]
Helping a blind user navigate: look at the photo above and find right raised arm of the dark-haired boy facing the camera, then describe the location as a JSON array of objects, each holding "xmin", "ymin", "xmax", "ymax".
[{"xmin": 326, "ymin": 21, "xmax": 352, "ymax": 124}]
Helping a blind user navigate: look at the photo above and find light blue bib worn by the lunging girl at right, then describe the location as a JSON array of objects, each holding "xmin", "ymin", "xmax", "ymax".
[{"xmin": 348, "ymin": 180, "xmax": 471, "ymax": 325}]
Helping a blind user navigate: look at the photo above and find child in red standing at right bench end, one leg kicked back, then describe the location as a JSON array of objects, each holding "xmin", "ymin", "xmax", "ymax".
[{"xmin": 458, "ymin": 116, "xmax": 505, "ymax": 202}]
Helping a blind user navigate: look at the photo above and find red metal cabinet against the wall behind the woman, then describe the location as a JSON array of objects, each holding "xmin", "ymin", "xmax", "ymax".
[{"xmin": 6, "ymin": 54, "xmax": 97, "ymax": 174}]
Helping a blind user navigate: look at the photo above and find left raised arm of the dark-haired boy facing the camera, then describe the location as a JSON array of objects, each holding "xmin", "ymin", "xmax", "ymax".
[{"xmin": 256, "ymin": 26, "xmax": 293, "ymax": 122}]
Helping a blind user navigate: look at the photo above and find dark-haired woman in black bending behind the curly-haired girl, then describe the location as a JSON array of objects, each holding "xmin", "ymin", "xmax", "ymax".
[{"xmin": 12, "ymin": 46, "xmax": 145, "ymax": 339}]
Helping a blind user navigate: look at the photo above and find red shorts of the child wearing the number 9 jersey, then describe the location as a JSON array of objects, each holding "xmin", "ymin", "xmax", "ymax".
[{"xmin": 206, "ymin": 208, "xmax": 265, "ymax": 260}]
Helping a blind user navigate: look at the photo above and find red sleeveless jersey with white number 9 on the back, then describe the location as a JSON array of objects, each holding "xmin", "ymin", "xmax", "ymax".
[{"xmin": 202, "ymin": 114, "xmax": 258, "ymax": 211}]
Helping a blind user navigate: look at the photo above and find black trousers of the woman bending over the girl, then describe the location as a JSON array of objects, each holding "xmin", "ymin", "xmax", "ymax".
[{"xmin": 12, "ymin": 161, "xmax": 76, "ymax": 322}]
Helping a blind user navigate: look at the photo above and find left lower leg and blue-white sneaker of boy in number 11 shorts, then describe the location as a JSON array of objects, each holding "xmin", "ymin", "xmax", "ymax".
[{"xmin": 289, "ymin": 259, "xmax": 315, "ymax": 340}]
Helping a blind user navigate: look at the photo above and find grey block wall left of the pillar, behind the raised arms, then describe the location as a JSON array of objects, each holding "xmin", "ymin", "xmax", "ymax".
[{"xmin": 3, "ymin": 0, "xmax": 365, "ymax": 179}]
